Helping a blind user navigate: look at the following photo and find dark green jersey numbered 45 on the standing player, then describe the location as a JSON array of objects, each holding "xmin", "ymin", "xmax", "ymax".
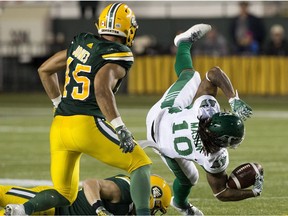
[{"xmin": 55, "ymin": 33, "xmax": 134, "ymax": 118}]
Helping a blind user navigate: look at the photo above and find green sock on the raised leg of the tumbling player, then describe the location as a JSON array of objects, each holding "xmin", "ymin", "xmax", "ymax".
[{"xmin": 174, "ymin": 42, "xmax": 194, "ymax": 77}]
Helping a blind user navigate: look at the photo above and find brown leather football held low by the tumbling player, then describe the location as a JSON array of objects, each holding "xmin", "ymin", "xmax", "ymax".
[{"xmin": 227, "ymin": 163, "xmax": 263, "ymax": 189}]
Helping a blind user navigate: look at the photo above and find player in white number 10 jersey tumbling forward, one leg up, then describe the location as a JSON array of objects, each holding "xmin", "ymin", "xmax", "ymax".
[{"xmin": 140, "ymin": 24, "xmax": 263, "ymax": 215}]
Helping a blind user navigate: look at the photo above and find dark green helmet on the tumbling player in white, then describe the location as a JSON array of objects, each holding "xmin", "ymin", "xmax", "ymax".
[{"xmin": 205, "ymin": 112, "xmax": 245, "ymax": 148}]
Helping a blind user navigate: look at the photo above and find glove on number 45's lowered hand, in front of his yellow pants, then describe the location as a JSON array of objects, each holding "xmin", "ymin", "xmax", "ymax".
[{"xmin": 115, "ymin": 125, "xmax": 136, "ymax": 153}]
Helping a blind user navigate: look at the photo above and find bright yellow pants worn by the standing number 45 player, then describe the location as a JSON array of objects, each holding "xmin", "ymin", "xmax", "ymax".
[{"xmin": 50, "ymin": 115, "xmax": 151, "ymax": 203}]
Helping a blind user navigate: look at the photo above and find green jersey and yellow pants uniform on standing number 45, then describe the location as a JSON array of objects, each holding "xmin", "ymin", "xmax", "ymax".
[{"xmin": 50, "ymin": 33, "xmax": 151, "ymax": 203}]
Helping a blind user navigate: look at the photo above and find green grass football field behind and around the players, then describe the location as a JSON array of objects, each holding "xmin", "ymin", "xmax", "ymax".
[{"xmin": 0, "ymin": 94, "xmax": 288, "ymax": 215}]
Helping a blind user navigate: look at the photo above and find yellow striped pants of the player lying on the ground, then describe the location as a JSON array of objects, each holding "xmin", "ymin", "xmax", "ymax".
[{"xmin": 0, "ymin": 185, "xmax": 55, "ymax": 216}]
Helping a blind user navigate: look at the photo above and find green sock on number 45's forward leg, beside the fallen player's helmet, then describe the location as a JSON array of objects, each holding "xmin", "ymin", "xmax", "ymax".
[{"xmin": 130, "ymin": 165, "xmax": 150, "ymax": 215}]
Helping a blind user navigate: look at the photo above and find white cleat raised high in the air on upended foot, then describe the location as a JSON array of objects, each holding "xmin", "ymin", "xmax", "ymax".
[{"xmin": 174, "ymin": 23, "xmax": 212, "ymax": 47}]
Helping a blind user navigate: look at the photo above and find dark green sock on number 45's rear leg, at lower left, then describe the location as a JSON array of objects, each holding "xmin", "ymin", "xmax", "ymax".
[{"xmin": 24, "ymin": 189, "xmax": 70, "ymax": 215}]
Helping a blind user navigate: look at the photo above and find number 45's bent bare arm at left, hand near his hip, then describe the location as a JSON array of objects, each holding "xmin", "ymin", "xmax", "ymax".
[{"xmin": 38, "ymin": 50, "xmax": 67, "ymax": 107}]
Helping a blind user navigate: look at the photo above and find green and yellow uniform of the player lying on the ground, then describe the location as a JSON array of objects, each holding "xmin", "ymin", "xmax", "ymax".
[{"xmin": 0, "ymin": 175, "xmax": 133, "ymax": 215}]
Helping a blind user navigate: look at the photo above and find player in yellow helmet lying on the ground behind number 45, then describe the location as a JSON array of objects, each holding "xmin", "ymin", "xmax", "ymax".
[{"xmin": 0, "ymin": 174, "xmax": 171, "ymax": 216}]
